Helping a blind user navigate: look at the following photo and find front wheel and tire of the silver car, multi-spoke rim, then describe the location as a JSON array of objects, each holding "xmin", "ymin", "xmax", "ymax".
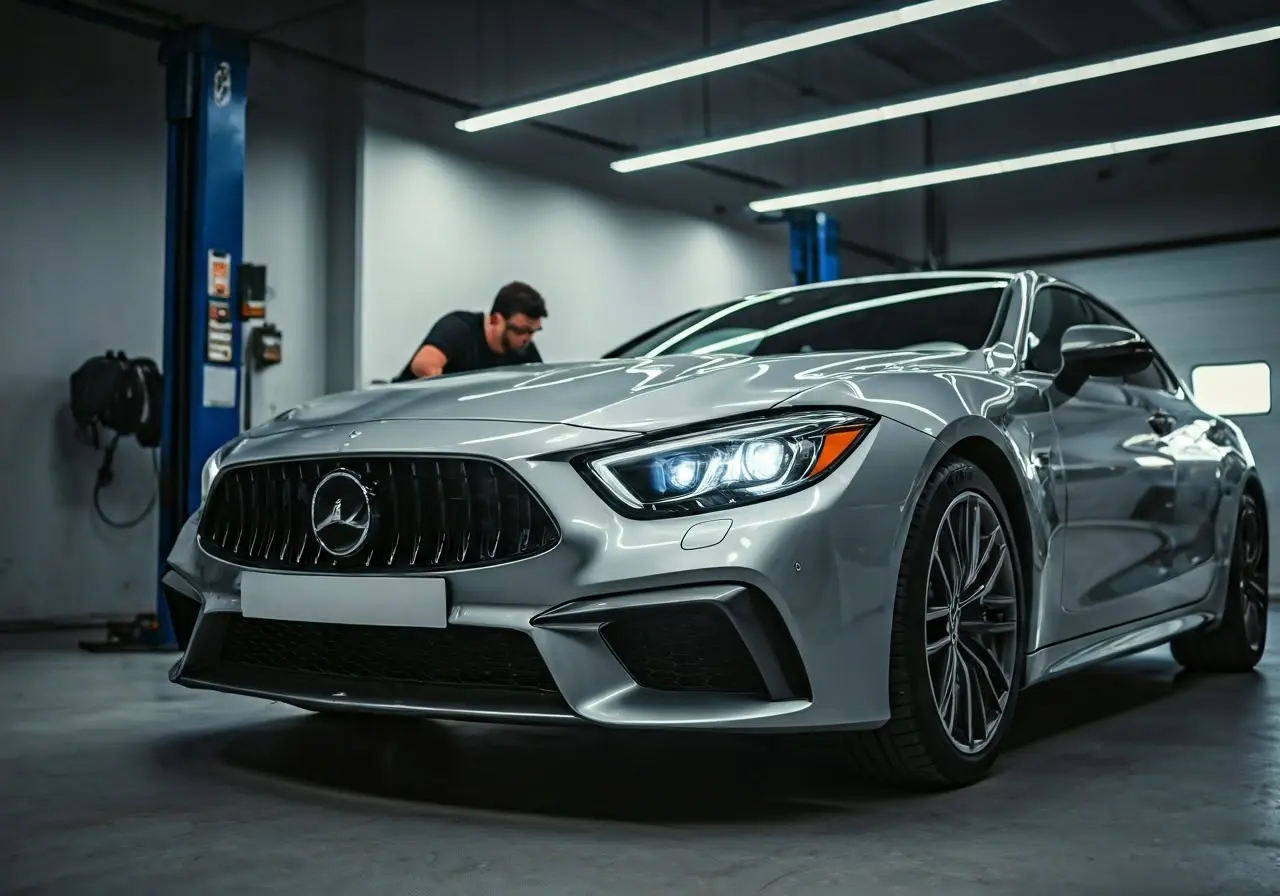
[{"xmin": 847, "ymin": 460, "xmax": 1025, "ymax": 788}]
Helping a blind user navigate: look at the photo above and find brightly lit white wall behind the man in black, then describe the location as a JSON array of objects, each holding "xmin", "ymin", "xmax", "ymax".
[{"xmin": 360, "ymin": 131, "xmax": 790, "ymax": 381}]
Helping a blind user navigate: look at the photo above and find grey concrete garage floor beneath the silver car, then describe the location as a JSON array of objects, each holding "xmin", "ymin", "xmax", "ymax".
[{"xmin": 0, "ymin": 617, "xmax": 1280, "ymax": 896}]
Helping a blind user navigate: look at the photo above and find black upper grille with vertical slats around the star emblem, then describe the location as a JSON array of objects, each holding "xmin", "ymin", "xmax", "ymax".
[{"xmin": 200, "ymin": 457, "xmax": 559, "ymax": 573}]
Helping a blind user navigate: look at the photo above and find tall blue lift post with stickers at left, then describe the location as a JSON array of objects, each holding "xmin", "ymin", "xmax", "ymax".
[{"xmin": 156, "ymin": 27, "xmax": 248, "ymax": 646}]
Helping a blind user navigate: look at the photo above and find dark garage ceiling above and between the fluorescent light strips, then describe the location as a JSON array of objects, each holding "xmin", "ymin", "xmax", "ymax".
[{"xmin": 55, "ymin": 0, "xmax": 1280, "ymax": 263}]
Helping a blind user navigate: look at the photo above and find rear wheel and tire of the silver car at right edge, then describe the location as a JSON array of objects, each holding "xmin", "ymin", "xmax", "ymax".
[{"xmin": 1170, "ymin": 494, "xmax": 1270, "ymax": 673}]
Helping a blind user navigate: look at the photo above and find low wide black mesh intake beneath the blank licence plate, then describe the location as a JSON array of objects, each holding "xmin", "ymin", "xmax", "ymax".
[{"xmin": 221, "ymin": 616, "xmax": 557, "ymax": 692}]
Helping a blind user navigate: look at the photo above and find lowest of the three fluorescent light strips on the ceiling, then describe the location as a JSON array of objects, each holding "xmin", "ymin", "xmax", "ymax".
[{"xmin": 750, "ymin": 115, "xmax": 1280, "ymax": 212}]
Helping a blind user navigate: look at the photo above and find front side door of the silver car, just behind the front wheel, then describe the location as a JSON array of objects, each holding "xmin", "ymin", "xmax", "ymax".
[{"xmin": 1023, "ymin": 282, "xmax": 1178, "ymax": 649}]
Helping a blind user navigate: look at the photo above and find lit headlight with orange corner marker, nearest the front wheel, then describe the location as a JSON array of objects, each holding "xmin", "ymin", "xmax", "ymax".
[{"xmin": 586, "ymin": 411, "xmax": 873, "ymax": 516}]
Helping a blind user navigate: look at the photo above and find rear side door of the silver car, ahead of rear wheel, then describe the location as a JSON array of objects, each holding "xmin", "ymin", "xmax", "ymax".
[{"xmin": 1091, "ymin": 298, "xmax": 1228, "ymax": 599}]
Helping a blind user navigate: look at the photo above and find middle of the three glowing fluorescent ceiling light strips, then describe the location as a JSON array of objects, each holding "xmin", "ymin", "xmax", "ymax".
[{"xmin": 611, "ymin": 26, "xmax": 1280, "ymax": 174}]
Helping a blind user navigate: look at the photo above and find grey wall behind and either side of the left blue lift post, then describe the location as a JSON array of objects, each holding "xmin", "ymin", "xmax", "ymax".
[{"xmin": 0, "ymin": 4, "xmax": 335, "ymax": 622}]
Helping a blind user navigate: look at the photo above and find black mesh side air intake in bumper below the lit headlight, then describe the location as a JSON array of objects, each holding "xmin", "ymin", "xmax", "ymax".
[{"xmin": 600, "ymin": 602, "xmax": 767, "ymax": 696}]
